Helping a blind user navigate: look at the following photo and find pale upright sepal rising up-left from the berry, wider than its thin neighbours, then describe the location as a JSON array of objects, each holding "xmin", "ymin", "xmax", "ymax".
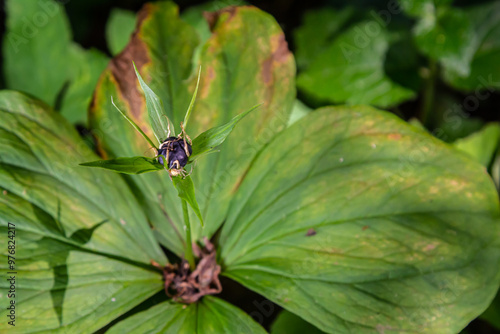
[{"xmin": 133, "ymin": 64, "xmax": 175, "ymax": 144}]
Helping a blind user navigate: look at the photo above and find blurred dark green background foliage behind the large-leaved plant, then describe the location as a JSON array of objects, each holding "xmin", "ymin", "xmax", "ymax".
[{"xmin": 0, "ymin": 0, "xmax": 500, "ymax": 333}]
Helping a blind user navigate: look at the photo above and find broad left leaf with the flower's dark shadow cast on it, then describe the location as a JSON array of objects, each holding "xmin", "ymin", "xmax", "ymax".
[{"xmin": 0, "ymin": 91, "xmax": 167, "ymax": 333}]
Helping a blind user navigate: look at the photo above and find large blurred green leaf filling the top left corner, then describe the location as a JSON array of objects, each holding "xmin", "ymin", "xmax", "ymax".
[{"xmin": 3, "ymin": 0, "xmax": 74, "ymax": 106}]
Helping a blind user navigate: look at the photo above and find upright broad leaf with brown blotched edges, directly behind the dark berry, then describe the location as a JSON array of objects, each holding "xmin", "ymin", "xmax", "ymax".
[{"xmin": 91, "ymin": 2, "xmax": 295, "ymax": 255}]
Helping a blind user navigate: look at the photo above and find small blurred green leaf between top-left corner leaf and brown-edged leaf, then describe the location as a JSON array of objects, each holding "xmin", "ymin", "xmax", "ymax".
[{"xmin": 61, "ymin": 44, "xmax": 109, "ymax": 125}]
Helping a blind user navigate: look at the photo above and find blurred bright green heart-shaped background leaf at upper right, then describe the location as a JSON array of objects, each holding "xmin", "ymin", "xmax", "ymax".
[{"xmin": 297, "ymin": 20, "xmax": 416, "ymax": 107}]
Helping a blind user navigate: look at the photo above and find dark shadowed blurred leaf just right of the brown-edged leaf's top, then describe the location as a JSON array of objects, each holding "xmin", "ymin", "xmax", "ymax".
[{"xmin": 293, "ymin": 7, "xmax": 355, "ymax": 69}]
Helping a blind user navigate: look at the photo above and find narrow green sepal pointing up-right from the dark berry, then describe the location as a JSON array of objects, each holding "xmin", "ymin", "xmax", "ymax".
[{"xmin": 189, "ymin": 104, "xmax": 261, "ymax": 161}]
